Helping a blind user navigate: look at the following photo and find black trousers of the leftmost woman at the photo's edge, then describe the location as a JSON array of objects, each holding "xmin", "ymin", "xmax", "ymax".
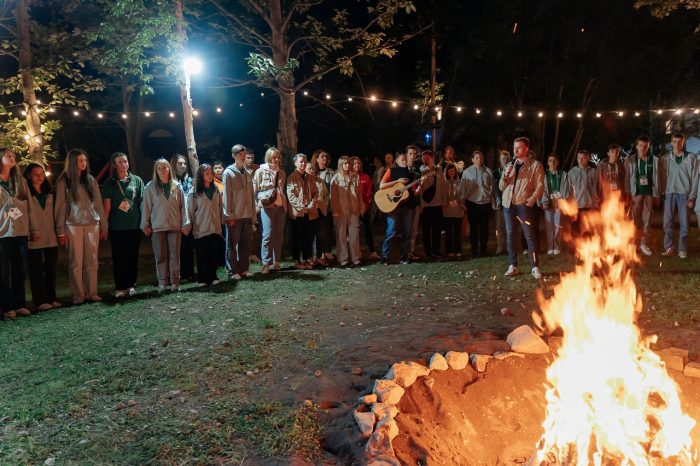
[{"xmin": 0, "ymin": 236, "xmax": 27, "ymax": 312}]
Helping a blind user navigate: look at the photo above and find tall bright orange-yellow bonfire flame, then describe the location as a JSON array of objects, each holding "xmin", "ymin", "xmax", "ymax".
[{"xmin": 529, "ymin": 193, "xmax": 698, "ymax": 466}]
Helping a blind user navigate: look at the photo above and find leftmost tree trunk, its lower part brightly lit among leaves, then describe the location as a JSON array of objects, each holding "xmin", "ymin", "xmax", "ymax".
[{"xmin": 16, "ymin": 0, "xmax": 44, "ymax": 166}]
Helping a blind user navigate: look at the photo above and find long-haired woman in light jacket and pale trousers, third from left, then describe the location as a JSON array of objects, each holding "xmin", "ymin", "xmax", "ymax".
[{"xmin": 55, "ymin": 149, "xmax": 107, "ymax": 304}]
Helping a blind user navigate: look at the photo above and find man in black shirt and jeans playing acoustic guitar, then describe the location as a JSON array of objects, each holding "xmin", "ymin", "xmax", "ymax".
[{"xmin": 379, "ymin": 154, "xmax": 422, "ymax": 264}]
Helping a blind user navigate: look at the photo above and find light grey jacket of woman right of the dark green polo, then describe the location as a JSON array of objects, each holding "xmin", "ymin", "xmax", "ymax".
[{"xmin": 141, "ymin": 181, "xmax": 190, "ymax": 232}]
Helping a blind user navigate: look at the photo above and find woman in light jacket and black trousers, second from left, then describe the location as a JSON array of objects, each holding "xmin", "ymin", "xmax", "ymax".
[{"xmin": 24, "ymin": 163, "xmax": 61, "ymax": 311}]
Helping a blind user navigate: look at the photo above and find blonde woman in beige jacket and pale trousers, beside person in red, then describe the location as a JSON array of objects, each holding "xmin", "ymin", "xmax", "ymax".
[{"xmin": 331, "ymin": 155, "xmax": 365, "ymax": 267}]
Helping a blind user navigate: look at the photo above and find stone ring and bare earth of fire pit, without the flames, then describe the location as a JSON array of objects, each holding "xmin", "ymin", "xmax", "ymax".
[{"xmin": 353, "ymin": 326, "xmax": 700, "ymax": 466}]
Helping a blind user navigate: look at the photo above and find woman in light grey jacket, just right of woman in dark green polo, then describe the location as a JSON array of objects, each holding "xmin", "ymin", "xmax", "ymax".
[{"xmin": 141, "ymin": 159, "xmax": 189, "ymax": 293}]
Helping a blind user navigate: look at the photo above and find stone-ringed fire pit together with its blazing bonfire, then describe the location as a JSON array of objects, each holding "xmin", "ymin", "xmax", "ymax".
[{"xmin": 355, "ymin": 191, "xmax": 700, "ymax": 466}]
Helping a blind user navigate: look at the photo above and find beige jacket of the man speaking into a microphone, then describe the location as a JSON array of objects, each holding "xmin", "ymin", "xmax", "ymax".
[{"xmin": 498, "ymin": 158, "xmax": 544, "ymax": 208}]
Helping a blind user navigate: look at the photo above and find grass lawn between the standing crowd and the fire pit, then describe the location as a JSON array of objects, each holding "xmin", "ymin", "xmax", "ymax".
[{"xmin": 0, "ymin": 225, "xmax": 700, "ymax": 465}]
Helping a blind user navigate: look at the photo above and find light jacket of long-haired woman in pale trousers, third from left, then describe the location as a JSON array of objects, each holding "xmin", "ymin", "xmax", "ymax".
[{"xmin": 54, "ymin": 176, "xmax": 107, "ymax": 236}]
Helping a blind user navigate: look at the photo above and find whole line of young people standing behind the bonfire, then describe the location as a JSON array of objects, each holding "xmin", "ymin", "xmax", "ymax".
[{"xmin": 0, "ymin": 133, "xmax": 700, "ymax": 318}]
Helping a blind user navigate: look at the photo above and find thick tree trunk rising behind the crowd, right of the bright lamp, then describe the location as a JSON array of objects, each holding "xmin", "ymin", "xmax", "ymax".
[{"xmin": 268, "ymin": 0, "xmax": 297, "ymax": 166}]
